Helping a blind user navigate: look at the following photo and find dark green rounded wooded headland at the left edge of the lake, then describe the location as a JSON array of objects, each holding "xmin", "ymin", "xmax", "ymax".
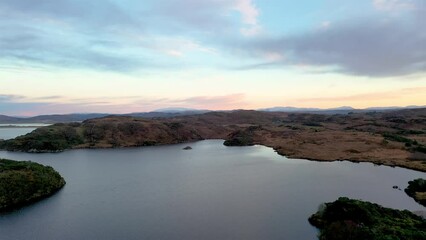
[{"xmin": 0, "ymin": 159, "xmax": 65, "ymax": 212}]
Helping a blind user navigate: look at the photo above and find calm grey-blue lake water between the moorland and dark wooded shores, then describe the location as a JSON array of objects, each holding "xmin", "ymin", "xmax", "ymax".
[{"xmin": 0, "ymin": 140, "xmax": 426, "ymax": 240}]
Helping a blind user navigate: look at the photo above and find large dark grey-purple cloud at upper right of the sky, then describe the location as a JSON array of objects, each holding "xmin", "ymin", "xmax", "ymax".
[{"xmin": 238, "ymin": 9, "xmax": 426, "ymax": 77}]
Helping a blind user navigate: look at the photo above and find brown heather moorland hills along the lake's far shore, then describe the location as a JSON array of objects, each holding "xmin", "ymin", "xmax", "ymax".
[{"xmin": 0, "ymin": 108, "xmax": 426, "ymax": 172}]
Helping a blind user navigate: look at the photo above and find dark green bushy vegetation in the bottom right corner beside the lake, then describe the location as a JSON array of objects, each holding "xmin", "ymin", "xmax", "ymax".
[{"xmin": 309, "ymin": 197, "xmax": 426, "ymax": 240}]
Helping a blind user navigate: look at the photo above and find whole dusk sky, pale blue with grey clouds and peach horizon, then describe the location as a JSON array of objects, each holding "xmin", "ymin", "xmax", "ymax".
[{"xmin": 0, "ymin": 0, "xmax": 426, "ymax": 116}]
